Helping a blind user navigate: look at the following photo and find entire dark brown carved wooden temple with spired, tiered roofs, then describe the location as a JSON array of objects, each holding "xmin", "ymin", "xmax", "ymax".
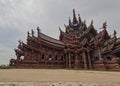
[{"xmin": 10, "ymin": 10, "xmax": 120, "ymax": 69}]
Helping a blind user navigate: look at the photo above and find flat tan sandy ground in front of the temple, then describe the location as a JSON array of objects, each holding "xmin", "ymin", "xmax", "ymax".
[{"xmin": 0, "ymin": 69, "xmax": 120, "ymax": 83}]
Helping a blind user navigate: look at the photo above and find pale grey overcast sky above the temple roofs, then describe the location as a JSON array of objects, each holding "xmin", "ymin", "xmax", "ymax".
[{"xmin": 0, "ymin": 0, "xmax": 120, "ymax": 64}]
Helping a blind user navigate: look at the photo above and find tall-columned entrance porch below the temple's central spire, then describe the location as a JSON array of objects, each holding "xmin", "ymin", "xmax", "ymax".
[{"xmin": 66, "ymin": 51, "xmax": 92, "ymax": 69}]
